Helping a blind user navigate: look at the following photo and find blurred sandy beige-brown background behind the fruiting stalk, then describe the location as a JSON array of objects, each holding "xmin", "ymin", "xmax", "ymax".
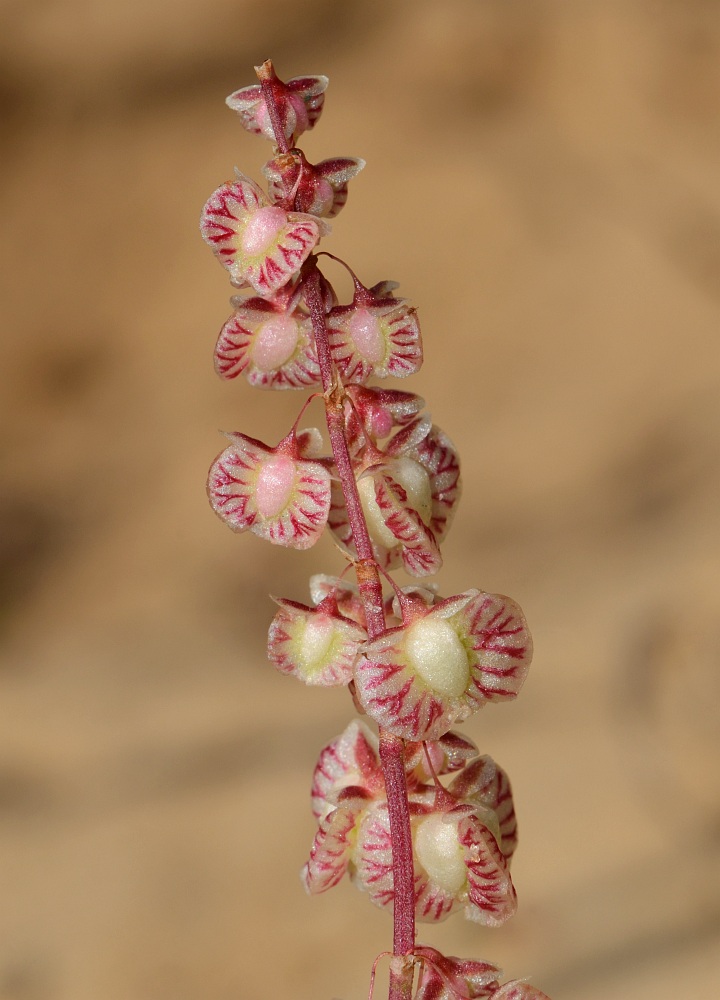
[{"xmin": 0, "ymin": 0, "xmax": 720, "ymax": 1000}]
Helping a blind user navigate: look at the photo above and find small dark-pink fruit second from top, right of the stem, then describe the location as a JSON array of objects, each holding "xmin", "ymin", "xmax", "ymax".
[{"xmin": 263, "ymin": 149, "xmax": 365, "ymax": 219}]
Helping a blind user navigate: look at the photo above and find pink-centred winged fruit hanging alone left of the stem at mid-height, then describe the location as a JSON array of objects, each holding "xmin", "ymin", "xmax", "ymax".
[{"xmin": 208, "ymin": 431, "xmax": 330, "ymax": 549}]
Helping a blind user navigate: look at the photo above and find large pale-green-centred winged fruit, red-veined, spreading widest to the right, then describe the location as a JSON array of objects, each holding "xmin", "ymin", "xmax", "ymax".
[{"xmin": 355, "ymin": 590, "xmax": 532, "ymax": 740}]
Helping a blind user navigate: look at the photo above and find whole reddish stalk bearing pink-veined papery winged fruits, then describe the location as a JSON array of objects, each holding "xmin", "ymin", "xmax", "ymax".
[{"xmin": 201, "ymin": 61, "xmax": 547, "ymax": 1000}]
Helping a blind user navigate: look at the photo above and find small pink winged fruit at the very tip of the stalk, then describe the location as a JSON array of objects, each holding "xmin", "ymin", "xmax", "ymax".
[{"xmin": 225, "ymin": 60, "xmax": 328, "ymax": 145}]
